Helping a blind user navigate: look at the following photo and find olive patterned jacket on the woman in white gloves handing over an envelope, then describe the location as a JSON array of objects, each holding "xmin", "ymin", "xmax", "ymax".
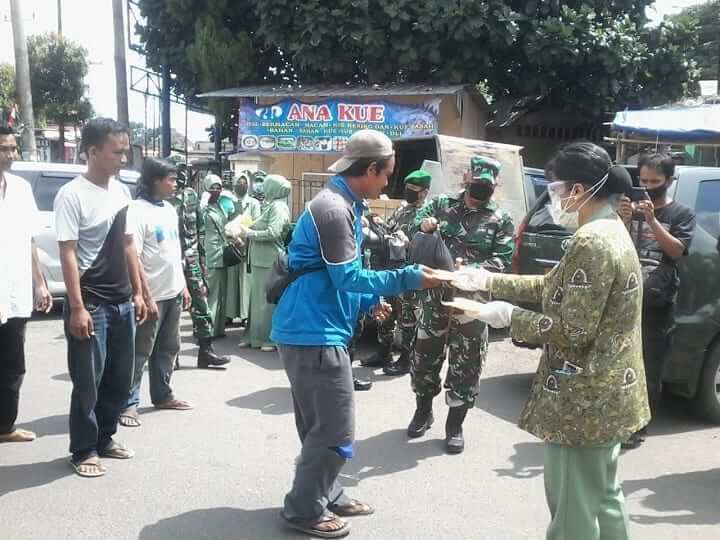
[{"xmin": 491, "ymin": 207, "xmax": 650, "ymax": 446}]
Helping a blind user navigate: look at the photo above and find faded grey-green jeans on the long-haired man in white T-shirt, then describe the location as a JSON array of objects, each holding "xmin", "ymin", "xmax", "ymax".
[{"xmin": 127, "ymin": 295, "xmax": 182, "ymax": 408}]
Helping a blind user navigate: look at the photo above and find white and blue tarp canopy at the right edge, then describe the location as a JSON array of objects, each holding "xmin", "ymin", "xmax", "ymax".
[{"xmin": 612, "ymin": 105, "xmax": 720, "ymax": 142}]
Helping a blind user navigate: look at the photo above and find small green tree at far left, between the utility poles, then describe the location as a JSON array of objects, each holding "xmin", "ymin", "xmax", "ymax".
[{"xmin": 28, "ymin": 33, "xmax": 93, "ymax": 160}]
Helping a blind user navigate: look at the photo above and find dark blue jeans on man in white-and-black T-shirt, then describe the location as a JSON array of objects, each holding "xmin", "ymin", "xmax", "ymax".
[{"xmin": 63, "ymin": 299, "xmax": 135, "ymax": 462}]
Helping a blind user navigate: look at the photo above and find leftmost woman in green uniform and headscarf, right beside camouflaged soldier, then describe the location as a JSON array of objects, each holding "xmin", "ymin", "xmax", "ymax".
[{"xmin": 200, "ymin": 174, "xmax": 227, "ymax": 337}]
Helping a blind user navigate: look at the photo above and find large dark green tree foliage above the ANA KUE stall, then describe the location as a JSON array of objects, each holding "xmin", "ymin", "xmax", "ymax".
[{"xmin": 135, "ymin": 0, "xmax": 697, "ymax": 119}]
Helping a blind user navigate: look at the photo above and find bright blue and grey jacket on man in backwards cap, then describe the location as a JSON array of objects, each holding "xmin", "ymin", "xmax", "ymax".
[{"xmin": 271, "ymin": 176, "xmax": 422, "ymax": 346}]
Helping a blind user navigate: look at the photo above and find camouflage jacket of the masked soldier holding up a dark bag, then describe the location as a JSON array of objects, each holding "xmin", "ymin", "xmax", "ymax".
[{"xmin": 412, "ymin": 192, "xmax": 515, "ymax": 272}]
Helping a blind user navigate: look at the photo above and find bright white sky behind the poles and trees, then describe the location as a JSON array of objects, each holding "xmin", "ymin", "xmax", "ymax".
[{"xmin": 0, "ymin": 0, "xmax": 703, "ymax": 141}]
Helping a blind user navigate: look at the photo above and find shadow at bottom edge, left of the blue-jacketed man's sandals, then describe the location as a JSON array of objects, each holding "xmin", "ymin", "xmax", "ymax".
[{"xmin": 138, "ymin": 507, "xmax": 299, "ymax": 540}]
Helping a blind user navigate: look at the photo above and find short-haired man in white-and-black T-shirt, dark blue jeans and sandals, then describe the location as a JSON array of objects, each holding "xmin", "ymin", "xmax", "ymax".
[{"xmin": 54, "ymin": 118, "xmax": 145, "ymax": 477}]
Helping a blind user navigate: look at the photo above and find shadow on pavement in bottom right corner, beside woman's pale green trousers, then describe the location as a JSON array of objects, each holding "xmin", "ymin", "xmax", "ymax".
[{"xmin": 623, "ymin": 468, "xmax": 720, "ymax": 525}]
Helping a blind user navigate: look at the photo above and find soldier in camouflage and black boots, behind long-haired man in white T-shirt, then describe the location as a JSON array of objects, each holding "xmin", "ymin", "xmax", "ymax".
[{"xmin": 170, "ymin": 163, "xmax": 230, "ymax": 368}]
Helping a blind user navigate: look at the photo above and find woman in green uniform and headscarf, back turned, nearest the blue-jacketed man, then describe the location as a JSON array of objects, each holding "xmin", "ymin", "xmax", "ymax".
[{"xmin": 240, "ymin": 174, "xmax": 291, "ymax": 352}]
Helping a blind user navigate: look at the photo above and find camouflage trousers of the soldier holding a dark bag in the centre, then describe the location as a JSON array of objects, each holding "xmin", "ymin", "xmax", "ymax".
[{"xmin": 410, "ymin": 291, "xmax": 488, "ymax": 407}]
